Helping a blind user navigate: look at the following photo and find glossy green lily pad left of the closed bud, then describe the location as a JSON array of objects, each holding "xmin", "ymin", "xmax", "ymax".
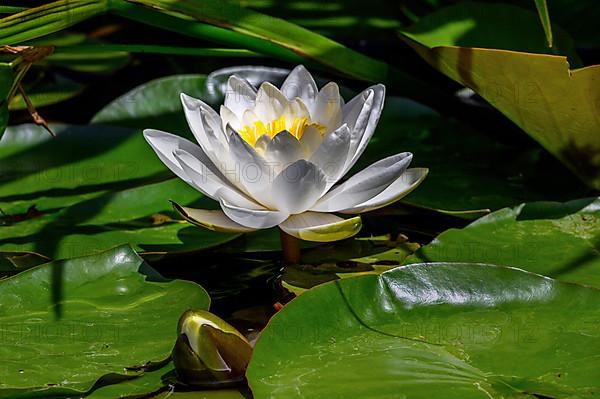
[{"xmin": 0, "ymin": 246, "xmax": 209, "ymax": 398}]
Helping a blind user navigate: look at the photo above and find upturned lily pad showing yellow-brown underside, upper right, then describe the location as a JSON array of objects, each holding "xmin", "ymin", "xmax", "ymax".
[{"xmin": 404, "ymin": 5, "xmax": 600, "ymax": 189}]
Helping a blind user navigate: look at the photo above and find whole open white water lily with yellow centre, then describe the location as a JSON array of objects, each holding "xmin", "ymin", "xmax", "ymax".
[{"xmin": 144, "ymin": 66, "xmax": 427, "ymax": 241}]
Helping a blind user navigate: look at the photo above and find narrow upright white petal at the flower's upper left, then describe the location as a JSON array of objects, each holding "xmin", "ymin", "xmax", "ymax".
[{"xmin": 181, "ymin": 93, "xmax": 227, "ymax": 157}]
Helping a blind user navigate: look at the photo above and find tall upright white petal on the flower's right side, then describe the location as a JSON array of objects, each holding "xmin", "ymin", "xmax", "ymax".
[{"xmin": 342, "ymin": 84, "xmax": 385, "ymax": 177}]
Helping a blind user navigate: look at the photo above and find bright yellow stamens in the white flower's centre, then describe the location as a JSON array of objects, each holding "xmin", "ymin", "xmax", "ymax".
[{"xmin": 238, "ymin": 115, "xmax": 326, "ymax": 146}]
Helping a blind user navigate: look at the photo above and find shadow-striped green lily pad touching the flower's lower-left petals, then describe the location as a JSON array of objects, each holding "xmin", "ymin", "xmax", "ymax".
[{"xmin": 0, "ymin": 179, "xmax": 239, "ymax": 259}]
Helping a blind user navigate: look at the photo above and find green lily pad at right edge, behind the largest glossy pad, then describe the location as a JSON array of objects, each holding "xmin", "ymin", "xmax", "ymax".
[{"xmin": 406, "ymin": 198, "xmax": 600, "ymax": 288}]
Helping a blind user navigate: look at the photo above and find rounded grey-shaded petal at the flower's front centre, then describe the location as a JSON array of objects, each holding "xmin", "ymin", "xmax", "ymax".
[{"xmin": 271, "ymin": 159, "xmax": 326, "ymax": 214}]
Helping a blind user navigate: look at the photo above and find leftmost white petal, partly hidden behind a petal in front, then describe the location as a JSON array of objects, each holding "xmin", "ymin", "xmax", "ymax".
[{"xmin": 144, "ymin": 129, "xmax": 216, "ymax": 184}]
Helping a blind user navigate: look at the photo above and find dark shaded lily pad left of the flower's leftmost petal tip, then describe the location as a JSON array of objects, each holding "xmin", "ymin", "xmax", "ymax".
[{"xmin": 0, "ymin": 124, "xmax": 172, "ymax": 215}]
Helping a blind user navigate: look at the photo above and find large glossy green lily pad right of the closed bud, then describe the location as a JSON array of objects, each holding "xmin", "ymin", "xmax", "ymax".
[{"xmin": 247, "ymin": 263, "xmax": 600, "ymax": 399}]
